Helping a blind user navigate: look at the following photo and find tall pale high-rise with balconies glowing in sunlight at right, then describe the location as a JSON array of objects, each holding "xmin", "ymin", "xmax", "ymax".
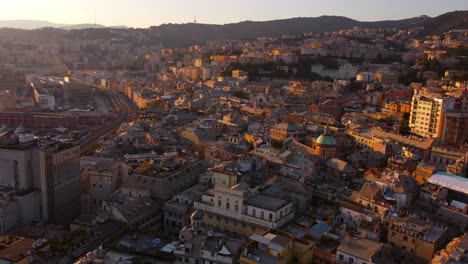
[{"xmin": 409, "ymin": 90, "xmax": 455, "ymax": 138}]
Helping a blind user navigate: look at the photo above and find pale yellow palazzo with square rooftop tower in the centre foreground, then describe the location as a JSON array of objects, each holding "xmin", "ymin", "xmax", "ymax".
[{"xmin": 193, "ymin": 172, "xmax": 294, "ymax": 236}]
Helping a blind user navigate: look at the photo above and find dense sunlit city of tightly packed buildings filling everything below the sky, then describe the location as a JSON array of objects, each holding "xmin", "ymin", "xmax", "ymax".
[{"xmin": 0, "ymin": 5, "xmax": 468, "ymax": 264}]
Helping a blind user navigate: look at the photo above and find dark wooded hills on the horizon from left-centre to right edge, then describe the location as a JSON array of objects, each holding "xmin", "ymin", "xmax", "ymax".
[{"xmin": 144, "ymin": 11, "xmax": 468, "ymax": 47}]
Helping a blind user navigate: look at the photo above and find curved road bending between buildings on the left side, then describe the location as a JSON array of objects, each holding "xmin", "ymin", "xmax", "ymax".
[{"xmin": 80, "ymin": 87, "xmax": 138, "ymax": 154}]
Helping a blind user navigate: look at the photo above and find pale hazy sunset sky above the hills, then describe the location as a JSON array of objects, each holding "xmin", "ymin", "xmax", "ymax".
[{"xmin": 0, "ymin": 0, "xmax": 468, "ymax": 27}]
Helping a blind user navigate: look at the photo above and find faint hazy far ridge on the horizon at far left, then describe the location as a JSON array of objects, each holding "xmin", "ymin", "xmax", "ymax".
[{"xmin": 0, "ymin": 19, "xmax": 127, "ymax": 30}]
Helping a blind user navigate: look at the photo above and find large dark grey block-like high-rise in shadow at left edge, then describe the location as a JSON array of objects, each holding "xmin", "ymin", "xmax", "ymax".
[{"xmin": 0, "ymin": 135, "xmax": 80, "ymax": 224}]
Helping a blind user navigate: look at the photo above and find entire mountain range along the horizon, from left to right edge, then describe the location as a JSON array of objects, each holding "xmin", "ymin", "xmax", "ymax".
[{"xmin": 0, "ymin": 11, "xmax": 468, "ymax": 47}]
